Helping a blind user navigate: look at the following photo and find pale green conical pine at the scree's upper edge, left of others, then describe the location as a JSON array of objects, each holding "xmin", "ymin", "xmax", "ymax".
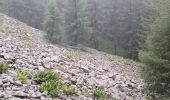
[{"xmin": 44, "ymin": 1, "xmax": 63, "ymax": 43}]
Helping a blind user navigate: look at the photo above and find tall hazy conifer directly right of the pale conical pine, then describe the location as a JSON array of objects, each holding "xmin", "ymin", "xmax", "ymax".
[{"xmin": 65, "ymin": 0, "xmax": 88, "ymax": 45}]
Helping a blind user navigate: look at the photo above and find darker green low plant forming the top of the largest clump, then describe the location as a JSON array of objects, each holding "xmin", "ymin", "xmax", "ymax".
[{"xmin": 34, "ymin": 71, "xmax": 59, "ymax": 84}]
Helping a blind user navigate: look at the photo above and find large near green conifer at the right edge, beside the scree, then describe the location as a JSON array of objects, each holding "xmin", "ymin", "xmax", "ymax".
[{"xmin": 140, "ymin": 0, "xmax": 170, "ymax": 92}]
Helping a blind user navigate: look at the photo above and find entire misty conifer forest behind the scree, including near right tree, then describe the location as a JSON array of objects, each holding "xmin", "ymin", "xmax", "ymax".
[{"xmin": 0, "ymin": 0, "xmax": 170, "ymax": 97}]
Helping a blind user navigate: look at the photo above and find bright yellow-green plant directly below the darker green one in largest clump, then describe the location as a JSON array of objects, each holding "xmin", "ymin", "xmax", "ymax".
[{"xmin": 40, "ymin": 80, "xmax": 62, "ymax": 98}]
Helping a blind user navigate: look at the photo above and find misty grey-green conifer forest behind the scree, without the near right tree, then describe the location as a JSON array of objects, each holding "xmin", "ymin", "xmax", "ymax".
[{"xmin": 0, "ymin": 0, "xmax": 148, "ymax": 59}]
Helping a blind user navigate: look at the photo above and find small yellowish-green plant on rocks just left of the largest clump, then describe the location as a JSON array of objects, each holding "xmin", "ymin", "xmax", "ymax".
[{"xmin": 16, "ymin": 71, "xmax": 29, "ymax": 84}]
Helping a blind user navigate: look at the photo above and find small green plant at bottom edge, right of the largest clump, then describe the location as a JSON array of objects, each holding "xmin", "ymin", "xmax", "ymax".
[{"xmin": 92, "ymin": 89, "xmax": 106, "ymax": 100}]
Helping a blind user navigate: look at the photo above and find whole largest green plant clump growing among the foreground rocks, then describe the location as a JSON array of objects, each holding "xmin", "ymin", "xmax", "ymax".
[{"xmin": 35, "ymin": 71, "xmax": 76, "ymax": 98}]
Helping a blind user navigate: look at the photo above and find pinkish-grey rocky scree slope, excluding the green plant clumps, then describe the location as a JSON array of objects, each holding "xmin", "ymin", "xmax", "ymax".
[{"xmin": 0, "ymin": 14, "xmax": 146, "ymax": 100}]
